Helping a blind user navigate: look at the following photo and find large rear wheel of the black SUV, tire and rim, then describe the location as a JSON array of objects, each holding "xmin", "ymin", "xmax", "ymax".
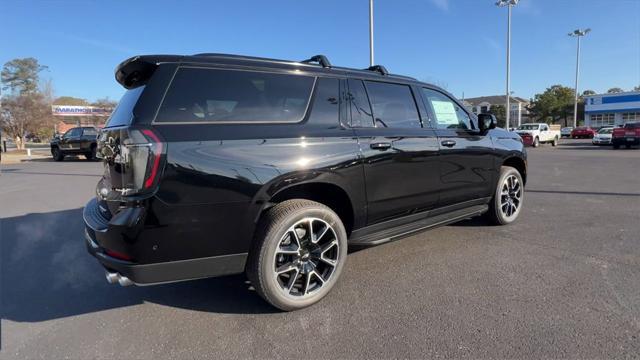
[{"xmin": 246, "ymin": 199, "xmax": 347, "ymax": 311}]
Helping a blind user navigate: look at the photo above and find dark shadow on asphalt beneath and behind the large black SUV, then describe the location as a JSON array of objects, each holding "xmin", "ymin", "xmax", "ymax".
[{"xmin": 0, "ymin": 209, "xmax": 277, "ymax": 322}]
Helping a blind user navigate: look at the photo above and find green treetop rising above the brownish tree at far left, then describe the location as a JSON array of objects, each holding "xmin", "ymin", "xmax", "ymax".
[{"xmin": 0, "ymin": 58, "xmax": 47, "ymax": 94}]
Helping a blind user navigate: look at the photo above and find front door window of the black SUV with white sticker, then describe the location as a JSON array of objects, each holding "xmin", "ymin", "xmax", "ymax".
[{"xmin": 422, "ymin": 88, "xmax": 471, "ymax": 129}]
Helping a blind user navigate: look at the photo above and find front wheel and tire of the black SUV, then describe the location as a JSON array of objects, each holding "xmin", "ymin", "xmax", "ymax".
[{"xmin": 487, "ymin": 166, "xmax": 524, "ymax": 225}]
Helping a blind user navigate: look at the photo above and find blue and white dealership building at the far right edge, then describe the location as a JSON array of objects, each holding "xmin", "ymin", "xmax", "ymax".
[{"xmin": 584, "ymin": 91, "xmax": 640, "ymax": 127}]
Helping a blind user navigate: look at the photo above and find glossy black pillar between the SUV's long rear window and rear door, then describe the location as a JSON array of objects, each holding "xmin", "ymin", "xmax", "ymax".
[{"xmin": 309, "ymin": 78, "xmax": 340, "ymax": 127}]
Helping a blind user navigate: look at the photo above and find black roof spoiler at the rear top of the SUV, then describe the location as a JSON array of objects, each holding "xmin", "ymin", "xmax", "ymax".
[{"xmin": 115, "ymin": 55, "xmax": 176, "ymax": 89}]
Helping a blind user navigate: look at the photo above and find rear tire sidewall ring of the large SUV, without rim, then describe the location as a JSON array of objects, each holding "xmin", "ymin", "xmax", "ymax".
[{"xmin": 258, "ymin": 204, "xmax": 347, "ymax": 310}]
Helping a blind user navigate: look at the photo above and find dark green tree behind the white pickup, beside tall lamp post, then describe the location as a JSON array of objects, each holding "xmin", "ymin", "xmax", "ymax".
[{"xmin": 528, "ymin": 85, "xmax": 575, "ymax": 125}]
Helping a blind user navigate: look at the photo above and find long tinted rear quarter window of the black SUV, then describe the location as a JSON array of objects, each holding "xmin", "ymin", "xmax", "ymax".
[{"xmin": 156, "ymin": 68, "xmax": 315, "ymax": 122}]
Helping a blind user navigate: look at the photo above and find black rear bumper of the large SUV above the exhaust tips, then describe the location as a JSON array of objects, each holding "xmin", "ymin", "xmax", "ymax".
[{"xmin": 83, "ymin": 199, "xmax": 248, "ymax": 285}]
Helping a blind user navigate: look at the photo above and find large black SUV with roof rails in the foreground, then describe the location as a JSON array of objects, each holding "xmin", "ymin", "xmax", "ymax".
[{"xmin": 83, "ymin": 54, "xmax": 527, "ymax": 310}]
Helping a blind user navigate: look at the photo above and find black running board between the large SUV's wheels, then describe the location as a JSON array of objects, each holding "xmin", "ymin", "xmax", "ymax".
[{"xmin": 349, "ymin": 205, "xmax": 489, "ymax": 246}]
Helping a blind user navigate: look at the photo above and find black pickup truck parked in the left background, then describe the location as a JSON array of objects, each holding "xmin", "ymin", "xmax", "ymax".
[{"xmin": 50, "ymin": 127, "xmax": 98, "ymax": 161}]
